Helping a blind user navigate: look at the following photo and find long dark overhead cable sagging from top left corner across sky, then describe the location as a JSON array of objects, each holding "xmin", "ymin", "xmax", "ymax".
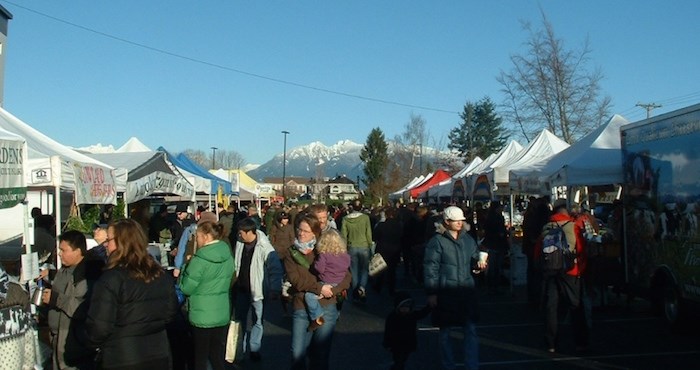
[{"xmin": 5, "ymin": 1, "xmax": 459, "ymax": 114}]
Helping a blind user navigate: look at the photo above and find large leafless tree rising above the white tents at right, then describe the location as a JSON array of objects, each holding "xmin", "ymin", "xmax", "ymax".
[{"xmin": 497, "ymin": 12, "xmax": 611, "ymax": 143}]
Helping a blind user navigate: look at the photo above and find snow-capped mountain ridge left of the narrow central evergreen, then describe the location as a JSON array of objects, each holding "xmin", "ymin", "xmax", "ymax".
[{"xmin": 248, "ymin": 140, "xmax": 363, "ymax": 181}]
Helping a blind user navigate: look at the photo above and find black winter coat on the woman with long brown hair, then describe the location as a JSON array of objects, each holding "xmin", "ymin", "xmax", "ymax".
[{"xmin": 86, "ymin": 267, "xmax": 178, "ymax": 370}]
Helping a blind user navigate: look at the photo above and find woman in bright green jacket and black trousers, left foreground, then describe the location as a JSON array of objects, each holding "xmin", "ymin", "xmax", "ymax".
[{"xmin": 180, "ymin": 215, "xmax": 234, "ymax": 370}]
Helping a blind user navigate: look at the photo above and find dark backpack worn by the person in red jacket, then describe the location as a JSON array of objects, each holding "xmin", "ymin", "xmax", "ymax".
[{"xmin": 539, "ymin": 221, "xmax": 576, "ymax": 275}]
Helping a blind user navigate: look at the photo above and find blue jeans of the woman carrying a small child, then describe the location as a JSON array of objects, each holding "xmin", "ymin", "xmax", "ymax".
[{"xmin": 291, "ymin": 304, "xmax": 338, "ymax": 370}]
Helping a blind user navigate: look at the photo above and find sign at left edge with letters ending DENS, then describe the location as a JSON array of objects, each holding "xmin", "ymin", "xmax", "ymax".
[{"xmin": 0, "ymin": 140, "xmax": 27, "ymax": 208}]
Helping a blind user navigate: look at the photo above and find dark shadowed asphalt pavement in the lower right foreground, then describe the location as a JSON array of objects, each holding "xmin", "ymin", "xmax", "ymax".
[{"xmin": 238, "ymin": 269, "xmax": 700, "ymax": 370}]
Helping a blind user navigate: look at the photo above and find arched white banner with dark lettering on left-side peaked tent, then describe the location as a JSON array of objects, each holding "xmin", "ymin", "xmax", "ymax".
[{"xmin": 124, "ymin": 171, "xmax": 194, "ymax": 204}]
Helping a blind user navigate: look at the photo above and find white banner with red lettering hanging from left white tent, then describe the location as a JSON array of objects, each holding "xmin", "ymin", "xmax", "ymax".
[{"xmin": 73, "ymin": 162, "xmax": 117, "ymax": 204}]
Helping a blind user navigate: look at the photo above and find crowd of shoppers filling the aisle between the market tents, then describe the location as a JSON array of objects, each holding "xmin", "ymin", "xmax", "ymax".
[{"xmin": 0, "ymin": 198, "xmax": 598, "ymax": 370}]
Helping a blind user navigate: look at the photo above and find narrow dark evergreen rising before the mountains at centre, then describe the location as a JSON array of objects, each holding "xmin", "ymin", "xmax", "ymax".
[{"xmin": 360, "ymin": 127, "xmax": 389, "ymax": 200}]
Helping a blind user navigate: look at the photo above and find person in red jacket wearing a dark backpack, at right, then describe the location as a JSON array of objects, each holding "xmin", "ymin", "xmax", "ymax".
[{"xmin": 534, "ymin": 199, "xmax": 589, "ymax": 353}]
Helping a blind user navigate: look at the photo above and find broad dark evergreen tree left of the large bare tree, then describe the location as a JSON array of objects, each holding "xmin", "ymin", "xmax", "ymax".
[{"xmin": 447, "ymin": 97, "xmax": 508, "ymax": 163}]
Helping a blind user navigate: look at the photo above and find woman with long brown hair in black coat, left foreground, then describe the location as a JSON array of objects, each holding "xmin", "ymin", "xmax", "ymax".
[{"xmin": 86, "ymin": 219, "xmax": 177, "ymax": 370}]
